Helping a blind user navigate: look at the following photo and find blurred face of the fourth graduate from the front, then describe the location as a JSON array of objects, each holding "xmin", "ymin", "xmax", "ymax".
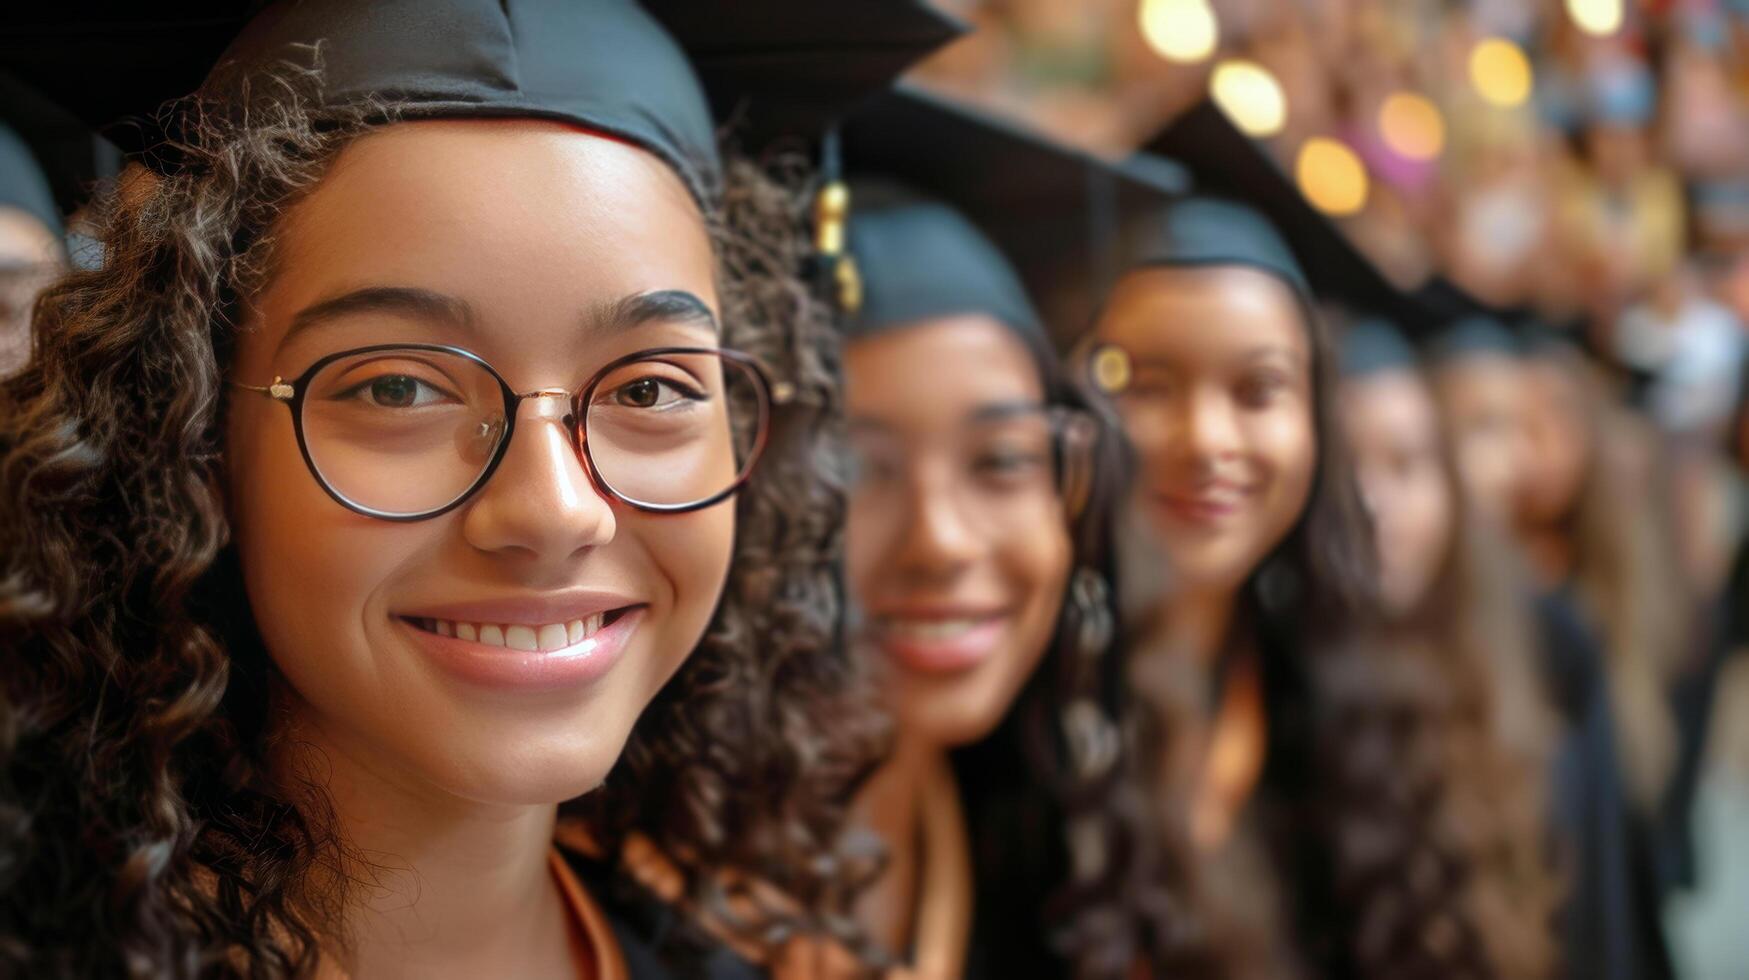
[{"xmin": 1341, "ymin": 368, "xmax": 1457, "ymax": 614}]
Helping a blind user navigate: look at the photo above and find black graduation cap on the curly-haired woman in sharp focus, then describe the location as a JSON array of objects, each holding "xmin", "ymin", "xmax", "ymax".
[{"xmin": 0, "ymin": 0, "xmax": 962, "ymax": 200}]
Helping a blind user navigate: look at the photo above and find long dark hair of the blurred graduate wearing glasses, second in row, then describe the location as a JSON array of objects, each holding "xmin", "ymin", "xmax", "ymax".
[{"xmin": 951, "ymin": 315, "xmax": 1140, "ymax": 977}]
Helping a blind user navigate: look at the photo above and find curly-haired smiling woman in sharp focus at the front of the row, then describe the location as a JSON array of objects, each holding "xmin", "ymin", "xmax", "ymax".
[{"xmin": 0, "ymin": 0, "xmax": 944, "ymax": 977}]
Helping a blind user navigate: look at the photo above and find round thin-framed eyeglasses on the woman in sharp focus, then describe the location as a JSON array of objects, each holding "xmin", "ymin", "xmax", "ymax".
[{"xmin": 233, "ymin": 343, "xmax": 791, "ymax": 522}]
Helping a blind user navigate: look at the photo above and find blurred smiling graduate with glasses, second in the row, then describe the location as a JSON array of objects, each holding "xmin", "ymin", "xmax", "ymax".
[{"xmin": 818, "ymin": 91, "xmax": 1161, "ymax": 980}]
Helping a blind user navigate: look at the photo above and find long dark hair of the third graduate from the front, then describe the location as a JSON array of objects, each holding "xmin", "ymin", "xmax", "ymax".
[{"xmin": 1098, "ymin": 273, "xmax": 1378, "ymax": 978}]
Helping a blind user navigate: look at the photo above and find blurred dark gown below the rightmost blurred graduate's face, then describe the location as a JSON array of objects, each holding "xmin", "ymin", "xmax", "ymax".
[{"xmin": 1534, "ymin": 592, "xmax": 1674, "ymax": 980}]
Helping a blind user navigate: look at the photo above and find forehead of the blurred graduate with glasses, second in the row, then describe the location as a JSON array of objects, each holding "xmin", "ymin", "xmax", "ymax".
[{"xmin": 845, "ymin": 315, "xmax": 1044, "ymax": 425}]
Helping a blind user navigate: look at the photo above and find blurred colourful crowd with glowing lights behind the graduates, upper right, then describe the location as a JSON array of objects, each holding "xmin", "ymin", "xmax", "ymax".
[{"xmin": 916, "ymin": 0, "xmax": 1749, "ymax": 977}]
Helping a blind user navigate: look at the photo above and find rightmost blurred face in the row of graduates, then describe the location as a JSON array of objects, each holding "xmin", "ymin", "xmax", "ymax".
[{"xmin": 1516, "ymin": 357, "xmax": 1593, "ymax": 530}]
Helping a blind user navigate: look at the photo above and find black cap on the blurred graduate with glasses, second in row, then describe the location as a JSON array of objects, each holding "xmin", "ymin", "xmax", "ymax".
[{"xmin": 841, "ymin": 84, "xmax": 1172, "ymax": 347}]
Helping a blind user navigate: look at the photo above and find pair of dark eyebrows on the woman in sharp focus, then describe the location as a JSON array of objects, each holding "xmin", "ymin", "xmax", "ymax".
[{"xmin": 280, "ymin": 285, "xmax": 719, "ymax": 347}]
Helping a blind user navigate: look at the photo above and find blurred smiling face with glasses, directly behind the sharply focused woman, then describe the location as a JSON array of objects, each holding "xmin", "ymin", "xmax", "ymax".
[{"xmin": 845, "ymin": 315, "xmax": 1074, "ymax": 746}]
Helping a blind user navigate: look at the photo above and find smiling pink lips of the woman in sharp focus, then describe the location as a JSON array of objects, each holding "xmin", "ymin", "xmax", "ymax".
[{"xmin": 397, "ymin": 606, "xmax": 644, "ymax": 691}]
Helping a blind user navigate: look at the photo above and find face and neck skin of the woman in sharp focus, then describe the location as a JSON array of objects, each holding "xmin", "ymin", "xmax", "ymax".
[{"xmin": 226, "ymin": 121, "xmax": 735, "ymax": 977}]
